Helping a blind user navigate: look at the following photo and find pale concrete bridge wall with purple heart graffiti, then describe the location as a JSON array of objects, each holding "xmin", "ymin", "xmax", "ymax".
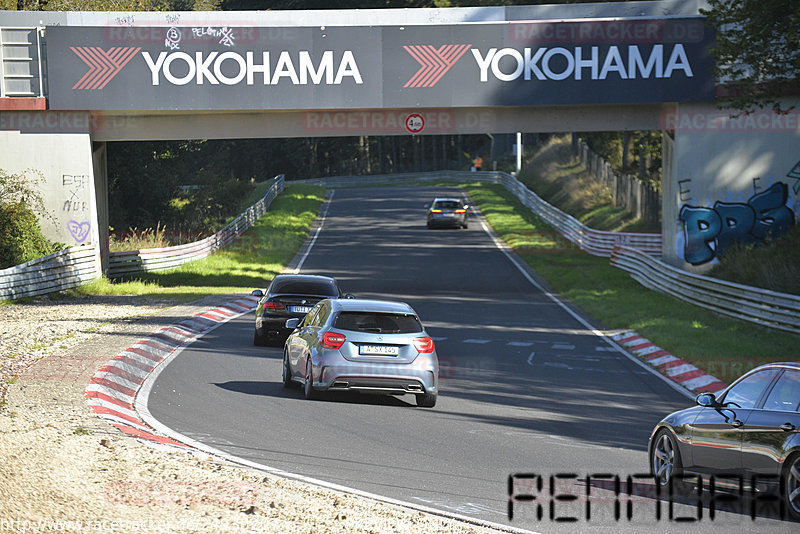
[{"xmin": 0, "ymin": 111, "xmax": 99, "ymax": 249}]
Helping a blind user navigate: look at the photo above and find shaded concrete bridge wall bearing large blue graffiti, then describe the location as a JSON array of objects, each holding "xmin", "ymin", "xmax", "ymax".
[{"xmin": 663, "ymin": 101, "xmax": 800, "ymax": 272}]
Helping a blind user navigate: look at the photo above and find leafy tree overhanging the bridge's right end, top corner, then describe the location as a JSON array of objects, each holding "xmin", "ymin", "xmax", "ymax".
[{"xmin": 701, "ymin": 0, "xmax": 800, "ymax": 113}]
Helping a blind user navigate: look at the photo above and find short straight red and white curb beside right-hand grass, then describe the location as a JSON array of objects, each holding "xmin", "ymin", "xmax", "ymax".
[{"xmin": 612, "ymin": 332, "xmax": 727, "ymax": 394}]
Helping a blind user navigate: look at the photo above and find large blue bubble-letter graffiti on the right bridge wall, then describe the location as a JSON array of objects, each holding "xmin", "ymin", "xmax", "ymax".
[{"xmin": 678, "ymin": 182, "xmax": 797, "ymax": 265}]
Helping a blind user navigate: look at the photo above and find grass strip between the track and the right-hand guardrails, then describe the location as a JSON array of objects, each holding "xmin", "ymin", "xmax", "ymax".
[{"xmin": 465, "ymin": 184, "xmax": 798, "ymax": 382}]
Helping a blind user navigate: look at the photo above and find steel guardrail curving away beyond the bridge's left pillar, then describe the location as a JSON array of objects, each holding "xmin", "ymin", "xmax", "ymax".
[{"xmin": 108, "ymin": 175, "xmax": 284, "ymax": 278}]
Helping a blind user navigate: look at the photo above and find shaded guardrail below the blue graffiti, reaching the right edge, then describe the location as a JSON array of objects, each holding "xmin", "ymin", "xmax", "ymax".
[{"xmin": 611, "ymin": 247, "xmax": 800, "ymax": 334}]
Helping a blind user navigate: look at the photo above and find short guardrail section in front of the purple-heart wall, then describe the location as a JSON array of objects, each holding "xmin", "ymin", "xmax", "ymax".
[{"xmin": 0, "ymin": 245, "xmax": 100, "ymax": 300}]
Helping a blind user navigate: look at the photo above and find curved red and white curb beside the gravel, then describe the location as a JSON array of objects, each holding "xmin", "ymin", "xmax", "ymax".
[{"xmin": 86, "ymin": 296, "xmax": 258, "ymax": 449}]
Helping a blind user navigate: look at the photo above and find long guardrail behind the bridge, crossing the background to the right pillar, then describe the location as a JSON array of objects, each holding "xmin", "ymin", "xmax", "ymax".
[{"xmin": 303, "ymin": 171, "xmax": 661, "ymax": 257}]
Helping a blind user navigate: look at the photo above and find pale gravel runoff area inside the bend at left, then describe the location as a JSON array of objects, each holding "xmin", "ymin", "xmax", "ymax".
[{"xmin": 0, "ymin": 295, "xmax": 506, "ymax": 533}]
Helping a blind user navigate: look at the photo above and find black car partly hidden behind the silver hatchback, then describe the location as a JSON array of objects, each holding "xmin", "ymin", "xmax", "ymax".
[{"xmin": 252, "ymin": 274, "xmax": 353, "ymax": 346}]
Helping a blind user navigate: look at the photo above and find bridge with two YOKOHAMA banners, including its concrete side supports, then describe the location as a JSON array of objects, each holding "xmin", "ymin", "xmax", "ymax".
[{"xmin": 0, "ymin": 0, "xmax": 800, "ymax": 270}]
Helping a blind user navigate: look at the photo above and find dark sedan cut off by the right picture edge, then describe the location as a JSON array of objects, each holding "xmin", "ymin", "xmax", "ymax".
[{"xmin": 648, "ymin": 362, "xmax": 800, "ymax": 519}]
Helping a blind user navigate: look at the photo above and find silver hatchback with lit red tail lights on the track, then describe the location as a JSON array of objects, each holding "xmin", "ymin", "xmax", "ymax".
[{"xmin": 283, "ymin": 299, "xmax": 439, "ymax": 408}]
